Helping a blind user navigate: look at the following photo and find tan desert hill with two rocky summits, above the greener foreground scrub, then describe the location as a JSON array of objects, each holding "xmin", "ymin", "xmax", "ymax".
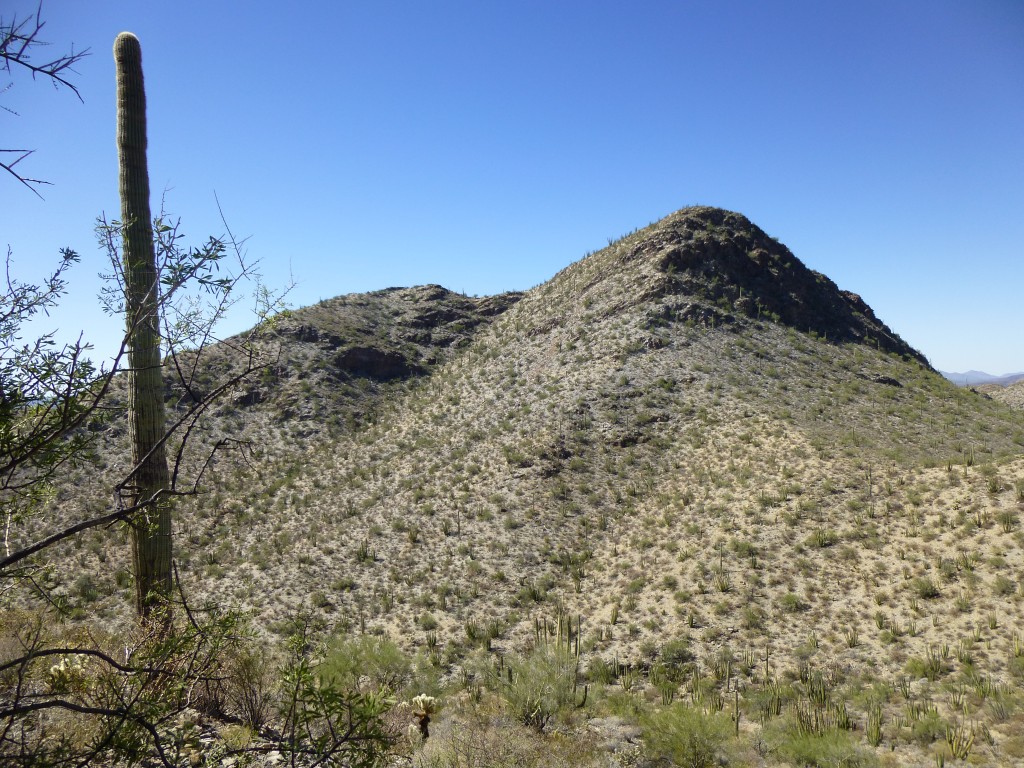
[{"xmin": 18, "ymin": 207, "xmax": 1024, "ymax": 765}]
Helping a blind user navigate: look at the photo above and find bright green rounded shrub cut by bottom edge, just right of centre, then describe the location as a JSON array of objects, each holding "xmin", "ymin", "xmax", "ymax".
[{"xmin": 641, "ymin": 703, "xmax": 732, "ymax": 768}]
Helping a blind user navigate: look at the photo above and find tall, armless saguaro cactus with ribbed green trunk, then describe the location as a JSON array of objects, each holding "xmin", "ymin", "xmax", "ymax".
[{"xmin": 114, "ymin": 32, "xmax": 171, "ymax": 617}]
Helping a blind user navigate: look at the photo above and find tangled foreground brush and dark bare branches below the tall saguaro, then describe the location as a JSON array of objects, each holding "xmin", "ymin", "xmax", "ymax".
[{"xmin": 0, "ymin": 608, "xmax": 395, "ymax": 766}]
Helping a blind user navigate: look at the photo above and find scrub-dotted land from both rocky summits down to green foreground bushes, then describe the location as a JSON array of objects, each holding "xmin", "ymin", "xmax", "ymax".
[{"xmin": 3, "ymin": 204, "xmax": 1024, "ymax": 766}]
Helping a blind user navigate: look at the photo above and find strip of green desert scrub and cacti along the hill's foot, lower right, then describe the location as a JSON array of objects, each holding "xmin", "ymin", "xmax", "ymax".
[{"xmin": 180, "ymin": 615, "xmax": 1024, "ymax": 766}]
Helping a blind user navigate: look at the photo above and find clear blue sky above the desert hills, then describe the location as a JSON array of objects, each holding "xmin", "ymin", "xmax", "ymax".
[{"xmin": 0, "ymin": 0, "xmax": 1024, "ymax": 374}]
